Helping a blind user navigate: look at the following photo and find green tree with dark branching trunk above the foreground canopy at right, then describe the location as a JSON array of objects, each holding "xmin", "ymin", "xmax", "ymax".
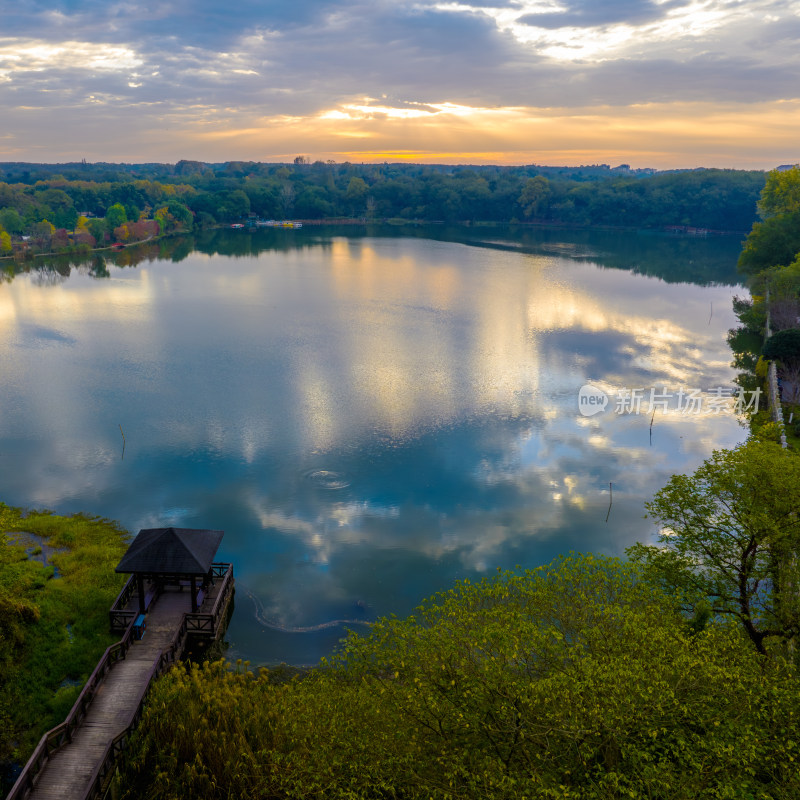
[{"xmin": 628, "ymin": 440, "xmax": 800, "ymax": 653}]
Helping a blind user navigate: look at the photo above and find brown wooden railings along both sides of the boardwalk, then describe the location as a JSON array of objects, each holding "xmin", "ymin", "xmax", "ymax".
[{"xmin": 6, "ymin": 563, "xmax": 233, "ymax": 800}]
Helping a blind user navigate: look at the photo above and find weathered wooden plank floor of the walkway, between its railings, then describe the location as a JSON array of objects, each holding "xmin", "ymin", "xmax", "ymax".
[{"xmin": 28, "ymin": 592, "xmax": 191, "ymax": 800}]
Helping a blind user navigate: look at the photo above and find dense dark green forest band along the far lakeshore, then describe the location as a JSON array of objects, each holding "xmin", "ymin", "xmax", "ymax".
[{"xmin": 0, "ymin": 157, "xmax": 765, "ymax": 255}]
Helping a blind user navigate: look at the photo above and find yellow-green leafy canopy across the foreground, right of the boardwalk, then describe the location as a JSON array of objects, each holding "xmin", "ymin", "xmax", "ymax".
[{"xmin": 118, "ymin": 556, "xmax": 800, "ymax": 800}]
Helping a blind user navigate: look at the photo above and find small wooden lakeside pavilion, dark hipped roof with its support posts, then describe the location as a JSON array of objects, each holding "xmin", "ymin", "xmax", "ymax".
[{"xmin": 115, "ymin": 528, "xmax": 225, "ymax": 614}]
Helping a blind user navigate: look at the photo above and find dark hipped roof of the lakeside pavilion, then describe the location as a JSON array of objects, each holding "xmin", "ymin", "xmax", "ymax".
[{"xmin": 116, "ymin": 528, "xmax": 225, "ymax": 575}]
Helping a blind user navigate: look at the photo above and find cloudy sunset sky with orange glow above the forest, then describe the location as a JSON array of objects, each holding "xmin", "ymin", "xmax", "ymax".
[{"xmin": 0, "ymin": 0, "xmax": 800, "ymax": 169}]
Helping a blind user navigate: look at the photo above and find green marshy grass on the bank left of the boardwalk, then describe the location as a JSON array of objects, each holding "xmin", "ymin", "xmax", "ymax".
[{"xmin": 0, "ymin": 503, "xmax": 129, "ymax": 763}]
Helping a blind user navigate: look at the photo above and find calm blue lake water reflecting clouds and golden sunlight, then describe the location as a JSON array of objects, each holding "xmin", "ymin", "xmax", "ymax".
[{"xmin": 0, "ymin": 223, "xmax": 745, "ymax": 663}]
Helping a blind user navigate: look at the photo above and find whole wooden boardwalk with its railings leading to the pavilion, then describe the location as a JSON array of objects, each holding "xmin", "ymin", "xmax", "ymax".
[{"xmin": 8, "ymin": 565, "xmax": 233, "ymax": 800}]
